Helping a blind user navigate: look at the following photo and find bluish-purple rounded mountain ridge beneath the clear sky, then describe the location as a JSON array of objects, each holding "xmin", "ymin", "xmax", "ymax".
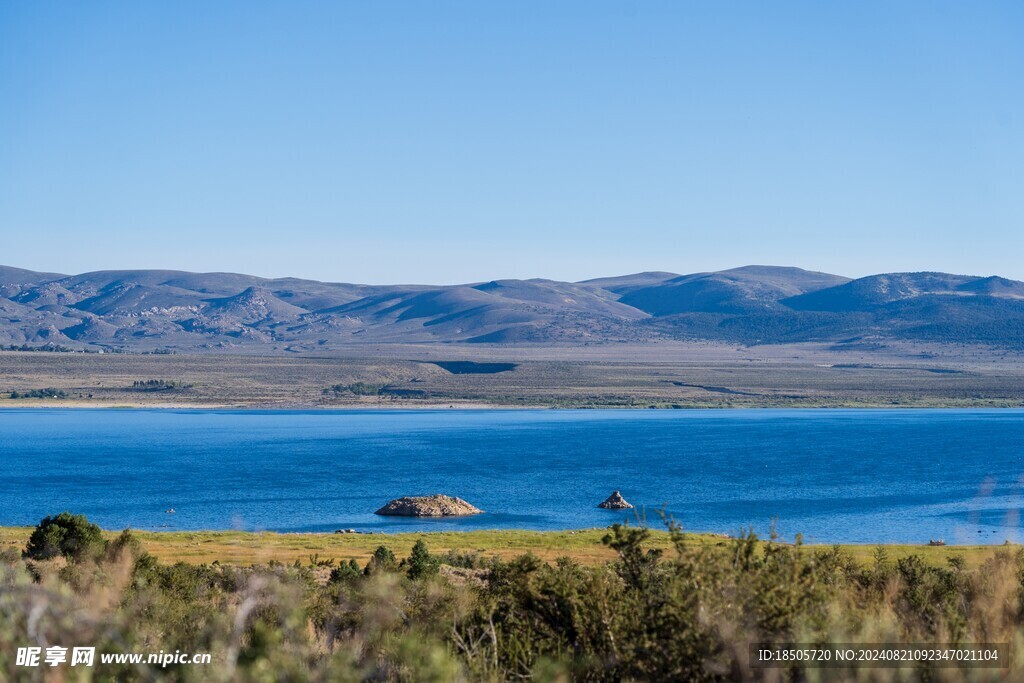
[{"xmin": 0, "ymin": 265, "xmax": 1024, "ymax": 353}]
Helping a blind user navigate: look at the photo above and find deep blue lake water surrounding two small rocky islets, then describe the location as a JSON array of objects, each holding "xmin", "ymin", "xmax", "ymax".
[{"xmin": 0, "ymin": 410, "xmax": 1024, "ymax": 543}]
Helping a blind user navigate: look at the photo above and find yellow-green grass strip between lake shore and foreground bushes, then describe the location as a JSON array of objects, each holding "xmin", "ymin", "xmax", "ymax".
[{"xmin": 0, "ymin": 527, "xmax": 1000, "ymax": 567}]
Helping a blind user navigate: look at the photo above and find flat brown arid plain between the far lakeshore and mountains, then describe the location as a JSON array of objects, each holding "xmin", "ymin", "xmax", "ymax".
[{"xmin": 0, "ymin": 343, "xmax": 1024, "ymax": 409}]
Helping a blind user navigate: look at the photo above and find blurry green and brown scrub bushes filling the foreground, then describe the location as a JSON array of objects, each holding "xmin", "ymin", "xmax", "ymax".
[{"xmin": 0, "ymin": 515, "xmax": 1024, "ymax": 682}]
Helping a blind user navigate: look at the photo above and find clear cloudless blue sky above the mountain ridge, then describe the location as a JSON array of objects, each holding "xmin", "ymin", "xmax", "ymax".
[{"xmin": 0, "ymin": 0, "xmax": 1024, "ymax": 284}]
